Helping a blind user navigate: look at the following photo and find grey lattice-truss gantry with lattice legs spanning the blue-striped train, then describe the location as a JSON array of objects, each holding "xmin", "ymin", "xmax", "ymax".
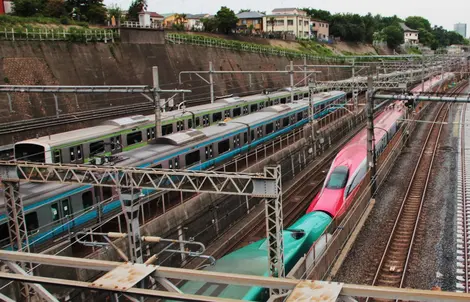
[{"xmin": 0, "ymin": 161, "xmax": 285, "ymax": 294}]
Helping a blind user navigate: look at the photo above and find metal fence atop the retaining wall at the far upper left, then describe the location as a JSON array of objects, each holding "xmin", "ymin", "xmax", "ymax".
[{"xmin": 0, "ymin": 28, "xmax": 119, "ymax": 43}]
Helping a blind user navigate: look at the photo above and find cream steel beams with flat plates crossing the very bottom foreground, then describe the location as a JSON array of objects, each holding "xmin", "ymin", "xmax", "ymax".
[{"xmin": 0, "ymin": 251, "xmax": 470, "ymax": 302}]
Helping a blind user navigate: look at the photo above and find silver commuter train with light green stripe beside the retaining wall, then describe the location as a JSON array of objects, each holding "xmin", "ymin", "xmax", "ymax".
[{"xmin": 15, "ymin": 88, "xmax": 343, "ymax": 164}]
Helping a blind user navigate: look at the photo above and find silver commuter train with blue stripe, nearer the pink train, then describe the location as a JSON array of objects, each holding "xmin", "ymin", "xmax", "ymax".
[{"xmin": 0, "ymin": 92, "xmax": 346, "ymax": 245}]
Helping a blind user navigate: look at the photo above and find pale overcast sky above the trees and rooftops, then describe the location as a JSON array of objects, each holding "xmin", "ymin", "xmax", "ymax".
[{"xmin": 104, "ymin": 0, "xmax": 470, "ymax": 30}]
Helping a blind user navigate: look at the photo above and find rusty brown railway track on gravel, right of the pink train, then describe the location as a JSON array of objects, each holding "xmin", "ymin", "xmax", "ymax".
[{"xmin": 366, "ymin": 86, "xmax": 464, "ymax": 301}]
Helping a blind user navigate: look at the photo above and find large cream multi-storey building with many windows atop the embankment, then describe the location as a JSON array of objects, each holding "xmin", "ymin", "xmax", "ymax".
[{"xmin": 263, "ymin": 8, "xmax": 310, "ymax": 39}]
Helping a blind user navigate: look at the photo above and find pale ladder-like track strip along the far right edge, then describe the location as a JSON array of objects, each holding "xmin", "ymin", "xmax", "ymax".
[{"xmin": 456, "ymin": 104, "xmax": 470, "ymax": 293}]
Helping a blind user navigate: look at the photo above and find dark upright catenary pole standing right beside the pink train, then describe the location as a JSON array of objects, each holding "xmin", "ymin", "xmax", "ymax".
[{"xmin": 367, "ymin": 74, "xmax": 376, "ymax": 193}]
